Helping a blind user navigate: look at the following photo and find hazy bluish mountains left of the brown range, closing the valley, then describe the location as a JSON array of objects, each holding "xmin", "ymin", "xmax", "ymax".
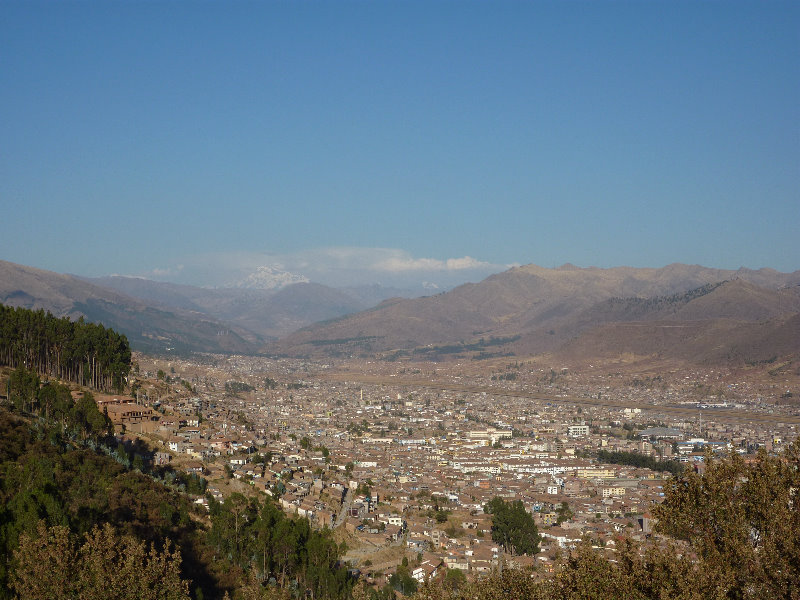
[{"xmin": 0, "ymin": 261, "xmax": 406, "ymax": 354}]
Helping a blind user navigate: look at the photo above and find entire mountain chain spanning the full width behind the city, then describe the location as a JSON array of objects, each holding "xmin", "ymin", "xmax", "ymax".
[{"xmin": 0, "ymin": 261, "xmax": 800, "ymax": 363}]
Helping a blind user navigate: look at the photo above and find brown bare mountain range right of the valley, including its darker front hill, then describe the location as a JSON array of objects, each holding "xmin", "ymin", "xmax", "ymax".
[{"xmin": 268, "ymin": 264, "xmax": 800, "ymax": 361}]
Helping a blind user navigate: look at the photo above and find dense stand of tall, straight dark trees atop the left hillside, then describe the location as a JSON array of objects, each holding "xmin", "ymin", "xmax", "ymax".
[{"xmin": 0, "ymin": 304, "xmax": 131, "ymax": 391}]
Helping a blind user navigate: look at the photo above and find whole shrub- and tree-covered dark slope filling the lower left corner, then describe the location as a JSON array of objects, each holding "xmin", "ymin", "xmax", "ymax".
[{"xmin": 0, "ymin": 398, "xmax": 352, "ymax": 600}]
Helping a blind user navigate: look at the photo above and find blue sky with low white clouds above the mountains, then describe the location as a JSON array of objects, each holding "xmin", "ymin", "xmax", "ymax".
[{"xmin": 0, "ymin": 0, "xmax": 800, "ymax": 284}]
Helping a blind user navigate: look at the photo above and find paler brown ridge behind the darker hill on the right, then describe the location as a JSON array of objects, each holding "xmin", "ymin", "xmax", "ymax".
[{"xmin": 268, "ymin": 265, "xmax": 800, "ymax": 355}]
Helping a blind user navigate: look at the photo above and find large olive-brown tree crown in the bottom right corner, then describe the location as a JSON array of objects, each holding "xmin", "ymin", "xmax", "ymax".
[{"xmin": 653, "ymin": 438, "xmax": 800, "ymax": 598}]
